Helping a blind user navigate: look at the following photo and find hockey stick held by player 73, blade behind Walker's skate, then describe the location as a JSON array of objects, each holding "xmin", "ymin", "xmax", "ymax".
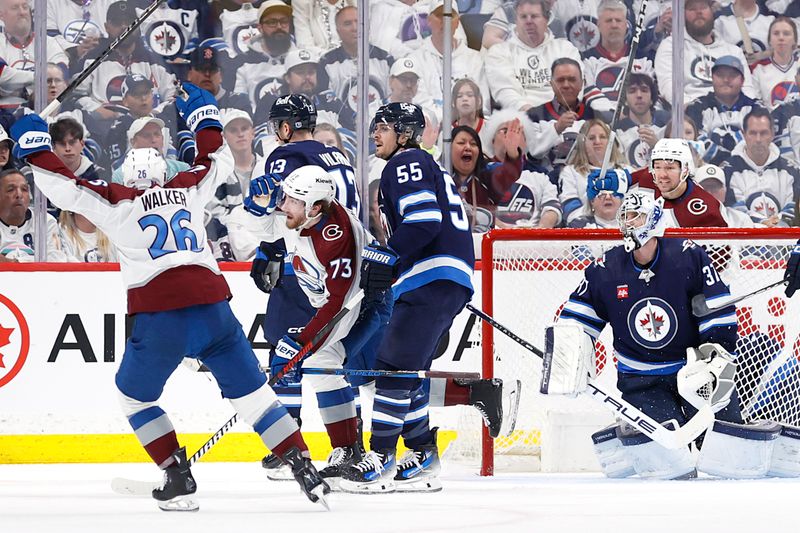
[{"xmin": 111, "ymin": 290, "xmax": 364, "ymax": 495}]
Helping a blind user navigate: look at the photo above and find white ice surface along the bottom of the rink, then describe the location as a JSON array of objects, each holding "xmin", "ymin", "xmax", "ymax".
[{"xmin": 0, "ymin": 463, "xmax": 800, "ymax": 533}]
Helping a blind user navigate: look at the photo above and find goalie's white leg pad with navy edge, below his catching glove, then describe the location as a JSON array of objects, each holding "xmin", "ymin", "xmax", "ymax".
[{"xmin": 697, "ymin": 420, "xmax": 781, "ymax": 479}]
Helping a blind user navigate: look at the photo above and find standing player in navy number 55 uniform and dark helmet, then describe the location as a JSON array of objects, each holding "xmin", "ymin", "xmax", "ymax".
[{"xmin": 340, "ymin": 103, "xmax": 482, "ymax": 492}]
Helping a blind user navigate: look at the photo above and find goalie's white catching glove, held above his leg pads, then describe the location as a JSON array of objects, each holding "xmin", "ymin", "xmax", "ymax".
[{"xmin": 677, "ymin": 343, "xmax": 736, "ymax": 413}]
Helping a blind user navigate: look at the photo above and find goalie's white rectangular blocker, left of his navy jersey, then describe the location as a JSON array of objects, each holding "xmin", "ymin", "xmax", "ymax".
[{"xmin": 539, "ymin": 324, "xmax": 595, "ymax": 398}]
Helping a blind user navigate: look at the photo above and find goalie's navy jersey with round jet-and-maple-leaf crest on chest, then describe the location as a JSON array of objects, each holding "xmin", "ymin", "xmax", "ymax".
[{"xmin": 559, "ymin": 238, "xmax": 737, "ymax": 375}]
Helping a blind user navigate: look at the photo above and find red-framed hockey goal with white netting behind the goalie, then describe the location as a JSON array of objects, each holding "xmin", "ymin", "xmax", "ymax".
[{"xmin": 446, "ymin": 228, "xmax": 800, "ymax": 475}]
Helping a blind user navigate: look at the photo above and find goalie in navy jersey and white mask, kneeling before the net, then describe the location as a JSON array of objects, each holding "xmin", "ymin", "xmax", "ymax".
[{"xmin": 543, "ymin": 191, "xmax": 796, "ymax": 479}]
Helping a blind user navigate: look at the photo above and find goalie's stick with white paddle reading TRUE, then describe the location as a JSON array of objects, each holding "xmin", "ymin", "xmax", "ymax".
[{"xmin": 467, "ymin": 304, "xmax": 714, "ymax": 450}]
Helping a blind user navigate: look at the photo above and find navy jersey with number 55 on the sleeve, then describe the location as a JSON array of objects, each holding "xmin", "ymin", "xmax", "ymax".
[{"xmin": 378, "ymin": 148, "xmax": 475, "ymax": 298}]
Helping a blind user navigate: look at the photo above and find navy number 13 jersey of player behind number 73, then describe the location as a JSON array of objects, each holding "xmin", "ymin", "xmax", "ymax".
[{"xmin": 264, "ymin": 140, "xmax": 361, "ymax": 216}]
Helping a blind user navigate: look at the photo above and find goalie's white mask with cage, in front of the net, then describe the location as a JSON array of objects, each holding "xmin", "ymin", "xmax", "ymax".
[{"xmin": 617, "ymin": 190, "xmax": 665, "ymax": 252}]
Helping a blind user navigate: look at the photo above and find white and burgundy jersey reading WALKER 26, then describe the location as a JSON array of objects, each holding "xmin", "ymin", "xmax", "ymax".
[{"xmin": 29, "ymin": 128, "xmax": 234, "ymax": 314}]
